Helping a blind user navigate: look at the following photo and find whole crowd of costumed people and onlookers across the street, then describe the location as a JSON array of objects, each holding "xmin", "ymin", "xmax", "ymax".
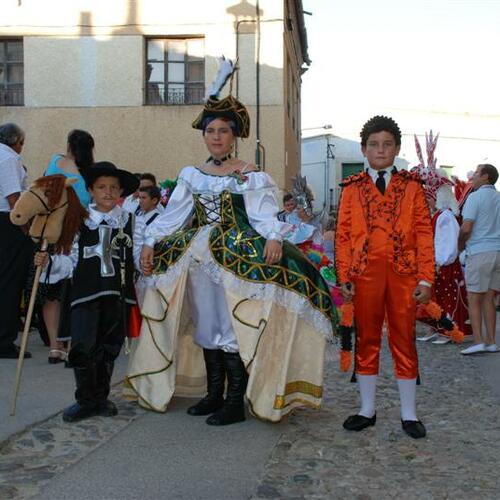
[{"xmin": 0, "ymin": 64, "xmax": 500, "ymax": 438}]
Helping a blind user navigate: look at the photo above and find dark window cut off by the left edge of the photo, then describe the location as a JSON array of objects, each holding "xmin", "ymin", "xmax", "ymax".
[{"xmin": 0, "ymin": 39, "xmax": 24, "ymax": 106}]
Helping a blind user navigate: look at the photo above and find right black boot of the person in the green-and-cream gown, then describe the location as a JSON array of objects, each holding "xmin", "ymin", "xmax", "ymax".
[{"xmin": 207, "ymin": 352, "xmax": 248, "ymax": 425}]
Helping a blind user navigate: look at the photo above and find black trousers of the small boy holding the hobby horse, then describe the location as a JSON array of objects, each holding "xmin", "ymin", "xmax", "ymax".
[{"xmin": 69, "ymin": 295, "xmax": 125, "ymax": 405}]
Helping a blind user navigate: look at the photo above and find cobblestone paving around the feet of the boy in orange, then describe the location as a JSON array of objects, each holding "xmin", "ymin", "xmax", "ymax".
[{"xmin": 255, "ymin": 343, "xmax": 500, "ymax": 500}]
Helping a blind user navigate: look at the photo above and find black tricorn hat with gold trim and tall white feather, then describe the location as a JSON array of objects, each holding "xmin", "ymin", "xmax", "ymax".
[{"xmin": 192, "ymin": 56, "xmax": 250, "ymax": 138}]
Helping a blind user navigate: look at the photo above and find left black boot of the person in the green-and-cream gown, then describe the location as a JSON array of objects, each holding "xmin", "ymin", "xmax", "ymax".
[{"xmin": 187, "ymin": 349, "xmax": 226, "ymax": 415}]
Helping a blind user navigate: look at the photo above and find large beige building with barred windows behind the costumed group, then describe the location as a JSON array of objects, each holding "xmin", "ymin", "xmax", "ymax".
[{"xmin": 0, "ymin": 0, "xmax": 310, "ymax": 188}]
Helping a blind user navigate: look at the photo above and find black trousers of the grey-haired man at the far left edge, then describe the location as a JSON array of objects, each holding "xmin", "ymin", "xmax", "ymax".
[{"xmin": 0, "ymin": 212, "xmax": 34, "ymax": 351}]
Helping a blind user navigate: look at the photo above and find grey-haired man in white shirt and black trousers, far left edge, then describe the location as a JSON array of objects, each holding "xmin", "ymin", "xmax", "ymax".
[{"xmin": 0, "ymin": 123, "xmax": 32, "ymax": 358}]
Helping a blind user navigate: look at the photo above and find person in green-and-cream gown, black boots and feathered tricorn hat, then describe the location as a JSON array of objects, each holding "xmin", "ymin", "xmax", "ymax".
[{"xmin": 125, "ymin": 60, "xmax": 334, "ymax": 425}]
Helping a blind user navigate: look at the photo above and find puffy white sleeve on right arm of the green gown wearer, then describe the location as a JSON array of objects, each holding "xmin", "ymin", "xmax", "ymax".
[{"xmin": 243, "ymin": 172, "xmax": 292, "ymax": 241}]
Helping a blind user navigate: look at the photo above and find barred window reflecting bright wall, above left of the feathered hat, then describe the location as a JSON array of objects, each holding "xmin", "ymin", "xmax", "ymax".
[{"xmin": 146, "ymin": 38, "xmax": 205, "ymax": 105}]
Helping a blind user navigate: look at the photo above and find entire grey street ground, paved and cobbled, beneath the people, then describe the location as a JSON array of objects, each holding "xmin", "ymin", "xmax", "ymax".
[{"xmin": 0, "ymin": 326, "xmax": 500, "ymax": 500}]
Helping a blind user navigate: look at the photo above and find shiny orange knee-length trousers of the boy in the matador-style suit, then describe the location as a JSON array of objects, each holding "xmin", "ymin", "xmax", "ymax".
[{"xmin": 353, "ymin": 257, "xmax": 418, "ymax": 379}]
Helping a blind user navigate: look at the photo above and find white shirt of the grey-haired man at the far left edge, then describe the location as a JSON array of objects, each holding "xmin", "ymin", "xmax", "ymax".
[{"xmin": 0, "ymin": 144, "xmax": 28, "ymax": 212}]
